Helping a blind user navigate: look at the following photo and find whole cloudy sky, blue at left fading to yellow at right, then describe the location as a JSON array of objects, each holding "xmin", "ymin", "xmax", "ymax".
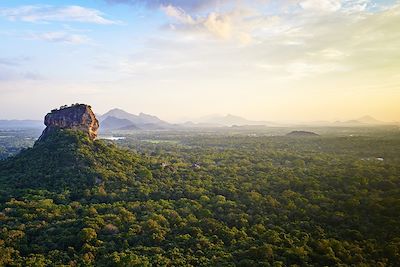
[{"xmin": 0, "ymin": 0, "xmax": 400, "ymax": 121}]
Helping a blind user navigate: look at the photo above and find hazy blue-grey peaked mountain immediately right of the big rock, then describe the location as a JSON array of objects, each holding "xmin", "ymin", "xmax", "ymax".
[{"xmin": 99, "ymin": 108, "xmax": 173, "ymax": 130}]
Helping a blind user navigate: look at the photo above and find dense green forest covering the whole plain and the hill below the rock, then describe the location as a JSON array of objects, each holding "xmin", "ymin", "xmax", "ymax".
[{"xmin": 0, "ymin": 128, "xmax": 400, "ymax": 266}]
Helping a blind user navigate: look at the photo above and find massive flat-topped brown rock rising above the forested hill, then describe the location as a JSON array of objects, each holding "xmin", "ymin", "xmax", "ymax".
[{"xmin": 39, "ymin": 104, "xmax": 99, "ymax": 141}]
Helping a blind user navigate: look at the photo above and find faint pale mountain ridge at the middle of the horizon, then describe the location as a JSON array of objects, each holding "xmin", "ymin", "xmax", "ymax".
[{"xmin": 196, "ymin": 114, "xmax": 275, "ymax": 126}]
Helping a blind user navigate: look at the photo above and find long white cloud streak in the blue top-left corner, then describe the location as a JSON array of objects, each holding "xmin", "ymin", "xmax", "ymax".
[{"xmin": 0, "ymin": 5, "xmax": 118, "ymax": 25}]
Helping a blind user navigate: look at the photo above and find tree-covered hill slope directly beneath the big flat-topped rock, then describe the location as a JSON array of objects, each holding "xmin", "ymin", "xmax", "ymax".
[{"xmin": 0, "ymin": 130, "xmax": 138, "ymax": 197}]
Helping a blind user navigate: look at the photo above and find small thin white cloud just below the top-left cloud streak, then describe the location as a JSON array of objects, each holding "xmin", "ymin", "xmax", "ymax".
[{"xmin": 26, "ymin": 31, "xmax": 91, "ymax": 45}]
